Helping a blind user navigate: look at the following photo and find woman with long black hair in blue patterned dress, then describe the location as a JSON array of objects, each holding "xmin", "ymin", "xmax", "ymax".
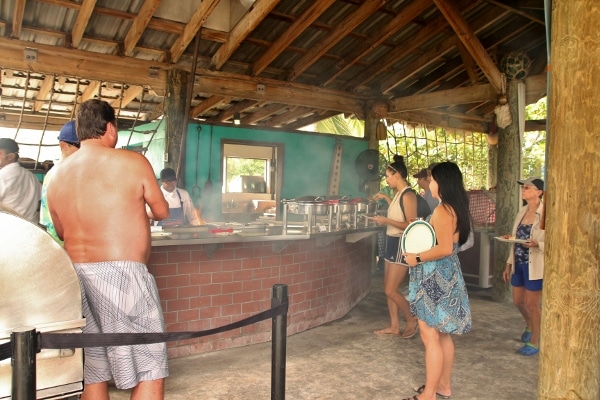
[{"xmin": 404, "ymin": 162, "xmax": 471, "ymax": 400}]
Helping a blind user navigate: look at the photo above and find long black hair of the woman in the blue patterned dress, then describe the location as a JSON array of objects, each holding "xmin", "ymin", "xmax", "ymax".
[{"xmin": 431, "ymin": 161, "xmax": 471, "ymax": 245}]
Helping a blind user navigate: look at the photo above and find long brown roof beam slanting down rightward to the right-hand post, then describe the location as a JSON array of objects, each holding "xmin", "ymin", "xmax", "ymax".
[{"xmin": 433, "ymin": 0, "xmax": 502, "ymax": 92}]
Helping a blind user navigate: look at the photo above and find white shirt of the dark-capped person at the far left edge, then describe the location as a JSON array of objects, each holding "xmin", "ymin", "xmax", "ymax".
[{"xmin": 0, "ymin": 162, "xmax": 42, "ymax": 223}]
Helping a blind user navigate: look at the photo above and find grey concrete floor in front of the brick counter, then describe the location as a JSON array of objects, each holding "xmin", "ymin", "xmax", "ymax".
[{"xmin": 111, "ymin": 274, "xmax": 539, "ymax": 400}]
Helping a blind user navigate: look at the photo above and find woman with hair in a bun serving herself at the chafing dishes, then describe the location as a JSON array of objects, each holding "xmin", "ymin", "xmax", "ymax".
[{"xmin": 372, "ymin": 154, "xmax": 417, "ymax": 339}]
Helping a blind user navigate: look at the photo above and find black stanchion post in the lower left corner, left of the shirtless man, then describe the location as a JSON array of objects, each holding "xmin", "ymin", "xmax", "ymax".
[{"xmin": 10, "ymin": 328, "xmax": 37, "ymax": 400}]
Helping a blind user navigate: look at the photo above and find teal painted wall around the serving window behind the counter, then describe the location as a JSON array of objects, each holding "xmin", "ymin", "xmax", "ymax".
[{"xmin": 117, "ymin": 122, "xmax": 368, "ymax": 214}]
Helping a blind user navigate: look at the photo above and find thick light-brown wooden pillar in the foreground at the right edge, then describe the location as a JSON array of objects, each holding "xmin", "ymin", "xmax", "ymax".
[{"xmin": 538, "ymin": 0, "xmax": 600, "ymax": 400}]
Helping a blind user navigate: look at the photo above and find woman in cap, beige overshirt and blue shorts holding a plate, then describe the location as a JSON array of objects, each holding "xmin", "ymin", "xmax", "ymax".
[{"xmin": 503, "ymin": 178, "xmax": 546, "ymax": 356}]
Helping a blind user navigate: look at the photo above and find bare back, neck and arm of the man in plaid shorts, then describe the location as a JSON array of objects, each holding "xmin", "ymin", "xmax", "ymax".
[{"xmin": 48, "ymin": 114, "xmax": 169, "ymax": 264}]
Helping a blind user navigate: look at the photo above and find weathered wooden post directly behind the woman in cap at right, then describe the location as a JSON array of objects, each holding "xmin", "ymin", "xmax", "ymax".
[{"xmin": 492, "ymin": 81, "xmax": 521, "ymax": 302}]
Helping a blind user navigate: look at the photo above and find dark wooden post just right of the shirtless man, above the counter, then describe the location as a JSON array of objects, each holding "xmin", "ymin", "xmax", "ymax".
[{"xmin": 165, "ymin": 69, "xmax": 189, "ymax": 187}]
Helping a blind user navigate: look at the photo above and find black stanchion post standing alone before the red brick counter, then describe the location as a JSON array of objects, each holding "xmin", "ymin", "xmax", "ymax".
[{"xmin": 271, "ymin": 284, "xmax": 288, "ymax": 400}]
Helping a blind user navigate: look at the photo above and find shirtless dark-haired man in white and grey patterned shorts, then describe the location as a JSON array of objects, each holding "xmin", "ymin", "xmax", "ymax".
[{"xmin": 47, "ymin": 99, "xmax": 169, "ymax": 400}]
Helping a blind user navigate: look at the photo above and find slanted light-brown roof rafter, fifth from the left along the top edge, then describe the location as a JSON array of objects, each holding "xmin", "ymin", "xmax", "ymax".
[{"xmin": 211, "ymin": 0, "xmax": 279, "ymax": 70}]
